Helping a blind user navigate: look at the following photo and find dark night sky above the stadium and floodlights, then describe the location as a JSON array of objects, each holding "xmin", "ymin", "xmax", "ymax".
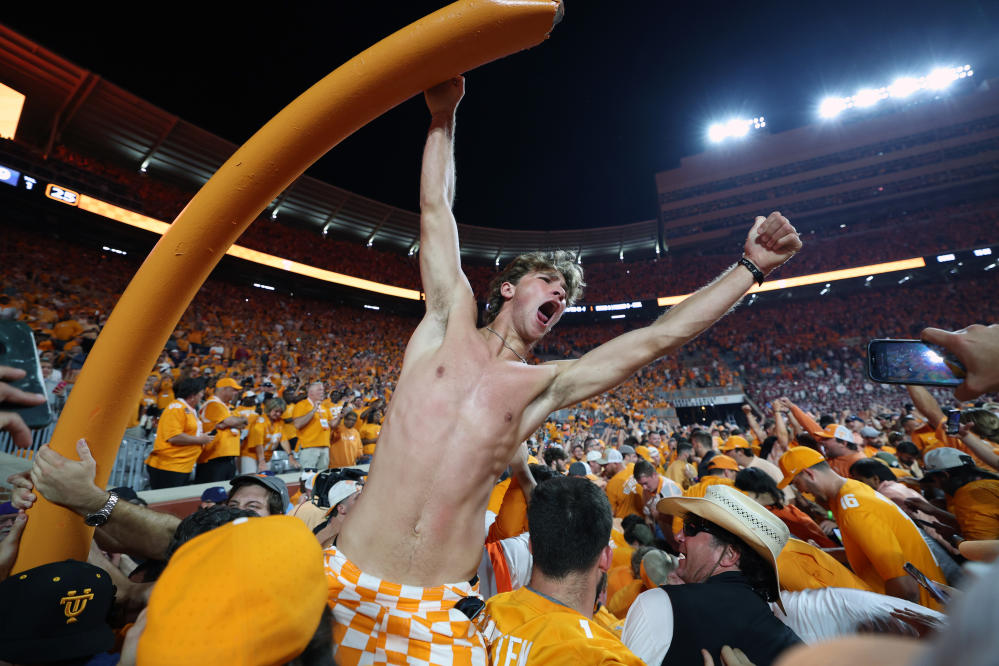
[{"xmin": 2, "ymin": 0, "xmax": 999, "ymax": 229}]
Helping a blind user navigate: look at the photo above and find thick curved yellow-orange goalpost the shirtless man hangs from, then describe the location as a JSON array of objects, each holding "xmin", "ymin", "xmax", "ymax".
[{"xmin": 13, "ymin": 0, "xmax": 563, "ymax": 572}]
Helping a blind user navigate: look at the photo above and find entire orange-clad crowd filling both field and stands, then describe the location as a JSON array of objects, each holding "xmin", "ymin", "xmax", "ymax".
[{"xmin": 0, "ymin": 127, "xmax": 999, "ymax": 666}]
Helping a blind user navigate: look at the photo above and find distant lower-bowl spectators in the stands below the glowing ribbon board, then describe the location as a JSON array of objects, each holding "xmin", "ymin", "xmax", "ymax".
[{"xmin": 0, "ymin": 202, "xmax": 995, "ymax": 440}]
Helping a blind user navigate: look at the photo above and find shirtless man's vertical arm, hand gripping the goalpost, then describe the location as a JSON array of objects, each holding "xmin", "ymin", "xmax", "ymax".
[{"xmin": 420, "ymin": 76, "xmax": 474, "ymax": 318}]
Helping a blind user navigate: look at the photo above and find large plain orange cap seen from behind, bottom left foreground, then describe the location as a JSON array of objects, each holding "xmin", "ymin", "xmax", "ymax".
[{"xmin": 137, "ymin": 516, "xmax": 328, "ymax": 666}]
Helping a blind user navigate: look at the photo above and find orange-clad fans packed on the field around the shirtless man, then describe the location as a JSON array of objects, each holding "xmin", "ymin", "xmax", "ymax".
[{"xmin": 0, "ymin": 314, "xmax": 999, "ymax": 665}]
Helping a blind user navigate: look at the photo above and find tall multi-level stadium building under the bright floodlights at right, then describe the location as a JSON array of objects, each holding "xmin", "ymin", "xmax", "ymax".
[{"xmin": 656, "ymin": 75, "xmax": 999, "ymax": 250}]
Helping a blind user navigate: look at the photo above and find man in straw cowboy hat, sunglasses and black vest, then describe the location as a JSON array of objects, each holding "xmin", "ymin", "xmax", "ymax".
[{"xmin": 621, "ymin": 485, "xmax": 801, "ymax": 666}]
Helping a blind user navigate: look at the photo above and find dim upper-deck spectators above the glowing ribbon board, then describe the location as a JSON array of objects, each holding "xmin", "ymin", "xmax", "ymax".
[{"xmin": 3, "ymin": 144, "xmax": 999, "ymax": 303}]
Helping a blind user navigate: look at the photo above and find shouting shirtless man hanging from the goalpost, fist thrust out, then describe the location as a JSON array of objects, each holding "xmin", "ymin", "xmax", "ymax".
[{"xmin": 327, "ymin": 77, "xmax": 801, "ymax": 663}]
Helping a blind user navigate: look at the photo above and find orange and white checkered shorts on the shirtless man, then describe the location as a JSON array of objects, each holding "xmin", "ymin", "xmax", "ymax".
[{"xmin": 325, "ymin": 547, "xmax": 489, "ymax": 666}]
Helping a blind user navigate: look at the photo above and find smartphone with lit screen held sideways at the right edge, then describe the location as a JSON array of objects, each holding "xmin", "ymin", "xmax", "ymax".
[{"xmin": 867, "ymin": 339, "xmax": 965, "ymax": 387}]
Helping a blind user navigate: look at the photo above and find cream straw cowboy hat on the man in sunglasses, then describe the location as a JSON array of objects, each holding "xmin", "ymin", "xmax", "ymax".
[{"xmin": 656, "ymin": 484, "xmax": 790, "ymax": 610}]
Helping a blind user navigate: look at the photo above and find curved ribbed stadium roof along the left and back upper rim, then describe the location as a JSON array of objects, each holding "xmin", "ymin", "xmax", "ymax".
[{"xmin": 0, "ymin": 25, "xmax": 658, "ymax": 263}]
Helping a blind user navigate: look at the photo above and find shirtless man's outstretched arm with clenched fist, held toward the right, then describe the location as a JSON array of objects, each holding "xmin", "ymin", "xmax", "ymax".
[{"xmin": 543, "ymin": 213, "xmax": 801, "ymax": 411}]
